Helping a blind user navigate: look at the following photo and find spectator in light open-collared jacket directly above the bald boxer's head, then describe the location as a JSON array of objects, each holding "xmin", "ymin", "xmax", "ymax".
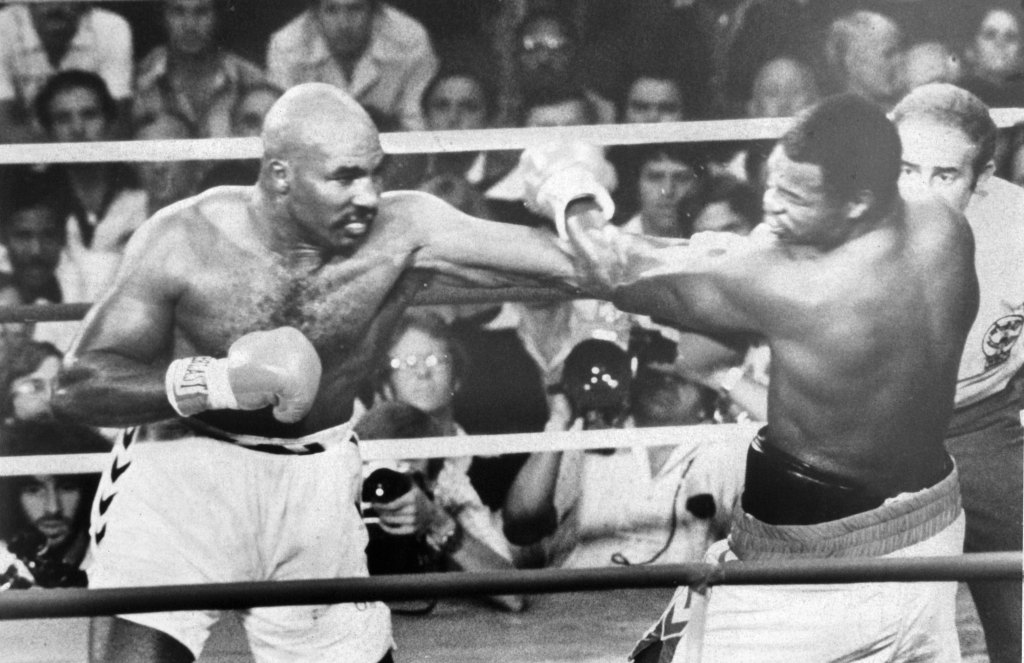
[{"xmin": 266, "ymin": 0, "xmax": 437, "ymax": 129}]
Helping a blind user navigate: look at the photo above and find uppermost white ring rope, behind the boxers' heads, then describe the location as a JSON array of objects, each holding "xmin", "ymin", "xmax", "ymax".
[{"xmin": 6, "ymin": 109, "xmax": 1024, "ymax": 164}]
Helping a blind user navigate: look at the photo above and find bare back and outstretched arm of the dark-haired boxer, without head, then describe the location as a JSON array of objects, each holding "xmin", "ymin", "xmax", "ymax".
[{"xmin": 567, "ymin": 154, "xmax": 978, "ymax": 495}]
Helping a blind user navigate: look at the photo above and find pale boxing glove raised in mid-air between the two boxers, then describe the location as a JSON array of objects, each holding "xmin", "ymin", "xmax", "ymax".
[{"xmin": 519, "ymin": 142, "xmax": 617, "ymax": 237}]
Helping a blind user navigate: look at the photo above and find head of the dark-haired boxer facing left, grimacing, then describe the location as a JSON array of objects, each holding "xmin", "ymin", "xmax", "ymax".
[{"xmin": 763, "ymin": 94, "xmax": 900, "ymax": 246}]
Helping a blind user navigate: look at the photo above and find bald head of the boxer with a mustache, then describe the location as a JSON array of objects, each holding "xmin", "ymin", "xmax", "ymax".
[{"xmin": 260, "ymin": 83, "xmax": 384, "ymax": 252}]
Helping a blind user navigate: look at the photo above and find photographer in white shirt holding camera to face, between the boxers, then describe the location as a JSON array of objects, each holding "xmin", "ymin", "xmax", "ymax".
[{"xmin": 504, "ymin": 339, "xmax": 741, "ymax": 568}]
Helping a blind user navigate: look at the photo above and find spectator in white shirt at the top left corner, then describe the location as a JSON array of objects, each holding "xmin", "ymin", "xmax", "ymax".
[{"xmin": 0, "ymin": 2, "xmax": 133, "ymax": 142}]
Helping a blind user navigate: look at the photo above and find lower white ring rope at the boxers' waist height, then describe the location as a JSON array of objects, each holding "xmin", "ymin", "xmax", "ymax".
[{"xmin": 0, "ymin": 423, "xmax": 761, "ymax": 476}]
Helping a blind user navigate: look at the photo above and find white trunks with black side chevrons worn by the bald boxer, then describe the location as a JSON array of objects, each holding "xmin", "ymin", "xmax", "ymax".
[{"xmin": 87, "ymin": 424, "xmax": 393, "ymax": 663}]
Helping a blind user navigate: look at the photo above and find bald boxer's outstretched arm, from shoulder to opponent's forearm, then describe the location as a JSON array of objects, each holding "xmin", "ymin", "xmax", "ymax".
[{"xmin": 393, "ymin": 192, "xmax": 574, "ymax": 289}]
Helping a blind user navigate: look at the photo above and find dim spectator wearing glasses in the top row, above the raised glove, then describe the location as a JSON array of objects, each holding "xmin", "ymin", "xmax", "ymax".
[{"xmin": 503, "ymin": 10, "xmax": 615, "ymax": 124}]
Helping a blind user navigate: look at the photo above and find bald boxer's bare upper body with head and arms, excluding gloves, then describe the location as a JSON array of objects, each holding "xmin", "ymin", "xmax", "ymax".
[{"xmin": 54, "ymin": 84, "xmax": 571, "ymax": 438}]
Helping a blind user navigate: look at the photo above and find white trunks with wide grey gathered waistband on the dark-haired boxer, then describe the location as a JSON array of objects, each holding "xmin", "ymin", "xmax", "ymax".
[{"xmin": 631, "ymin": 452, "xmax": 964, "ymax": 663}]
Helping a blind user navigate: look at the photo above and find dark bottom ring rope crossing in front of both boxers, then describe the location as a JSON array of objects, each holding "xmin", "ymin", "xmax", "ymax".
[{"xmin": 0, "ymin": 552, "xmax": 1024, "ymax": 620}]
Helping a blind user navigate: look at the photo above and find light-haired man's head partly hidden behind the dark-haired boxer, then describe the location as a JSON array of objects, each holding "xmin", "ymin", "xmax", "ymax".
[{"xmin": 892, "ymin": 83, "xmax": 996, "ymax": 211}]
